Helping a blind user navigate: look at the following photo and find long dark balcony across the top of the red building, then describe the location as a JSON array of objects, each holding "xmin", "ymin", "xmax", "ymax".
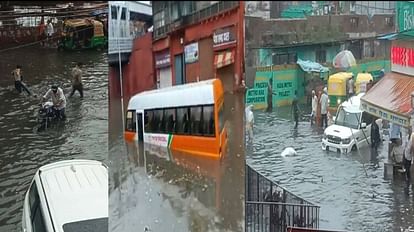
[{"xmin": 154, "ymin": 1, "xmax": 239, "ymax": 39}]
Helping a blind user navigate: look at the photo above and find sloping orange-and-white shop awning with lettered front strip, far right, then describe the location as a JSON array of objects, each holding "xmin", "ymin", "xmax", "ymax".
[{"xmin": 361, "ymin": 72, "xmax": 414, "ymax": 127}]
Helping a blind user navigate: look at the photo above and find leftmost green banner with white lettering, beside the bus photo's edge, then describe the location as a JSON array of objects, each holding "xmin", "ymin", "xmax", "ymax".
[{"xmin": 246, "ymin": 78, "xmax": 268, "ymax": 109}]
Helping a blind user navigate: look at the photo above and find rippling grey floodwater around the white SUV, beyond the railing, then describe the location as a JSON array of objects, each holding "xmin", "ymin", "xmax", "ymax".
[{"xmin": 246, "ymin": 107, "xmax": 414, "ymax": 231}]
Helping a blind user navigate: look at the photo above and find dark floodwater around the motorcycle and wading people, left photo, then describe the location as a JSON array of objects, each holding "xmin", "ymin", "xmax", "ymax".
[{"xmin": 0, "ymin": 48, "xmax": 108, "ymax": 231}]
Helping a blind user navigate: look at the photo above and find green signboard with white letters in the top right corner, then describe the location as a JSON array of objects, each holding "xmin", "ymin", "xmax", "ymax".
[{"xmin": 397, "ymin": 1, "xmax": 414, "ymax": 36}]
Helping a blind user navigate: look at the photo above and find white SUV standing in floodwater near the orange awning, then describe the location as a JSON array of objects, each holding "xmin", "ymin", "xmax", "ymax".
[{"xmin": 322, "ymin": 93, "xmax": 381, "ymax": 153}]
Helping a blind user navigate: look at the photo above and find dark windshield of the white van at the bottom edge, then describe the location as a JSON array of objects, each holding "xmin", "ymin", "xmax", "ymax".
[{"xmin": 63, "ymin": 217, "xmax": 108, "ymax": 232}]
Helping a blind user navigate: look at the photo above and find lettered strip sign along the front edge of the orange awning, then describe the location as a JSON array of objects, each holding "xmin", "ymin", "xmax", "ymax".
[{"xmin": 361, "ymin": 100, "xmax": 410, "ymax": 127}]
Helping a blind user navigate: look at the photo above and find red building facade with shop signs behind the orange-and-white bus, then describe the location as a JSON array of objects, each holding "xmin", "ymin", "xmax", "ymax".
[{"xmin": 152, "ymin": 1, "xmax": 244, "ymax": 91}]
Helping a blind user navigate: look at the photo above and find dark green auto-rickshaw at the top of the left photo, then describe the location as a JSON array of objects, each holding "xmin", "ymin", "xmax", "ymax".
[{"xmin": 58, "ymin": 18, "xmax": 108, "ymax": 50}]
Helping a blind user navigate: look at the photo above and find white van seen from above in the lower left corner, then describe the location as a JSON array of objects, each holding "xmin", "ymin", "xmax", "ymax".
[{"xmin": 22, "ymin": 160, "xmax": 108, "ymax": 232}]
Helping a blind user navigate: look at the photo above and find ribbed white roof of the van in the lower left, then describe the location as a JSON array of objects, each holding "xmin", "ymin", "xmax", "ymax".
[{"xmin": 38, "ymin": 160, "xmax": 108, "ymax": 232}]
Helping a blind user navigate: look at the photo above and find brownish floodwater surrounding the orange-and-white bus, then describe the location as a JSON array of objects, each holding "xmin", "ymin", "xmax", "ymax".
[{"xmin": 109, "ymin": 91, "xmax": 245, "ymax": 232}]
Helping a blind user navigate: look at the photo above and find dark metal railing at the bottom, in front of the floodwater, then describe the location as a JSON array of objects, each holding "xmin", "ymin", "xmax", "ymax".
[{"xmin": 245, "ymin": 165, "xmax": 320, "ymax": 232}]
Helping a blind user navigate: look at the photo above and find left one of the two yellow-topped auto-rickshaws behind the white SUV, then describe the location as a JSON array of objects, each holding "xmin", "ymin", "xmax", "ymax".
[{"xmin": 328, "ymin": 72, "xmax": 353, "ymax": 108}]
